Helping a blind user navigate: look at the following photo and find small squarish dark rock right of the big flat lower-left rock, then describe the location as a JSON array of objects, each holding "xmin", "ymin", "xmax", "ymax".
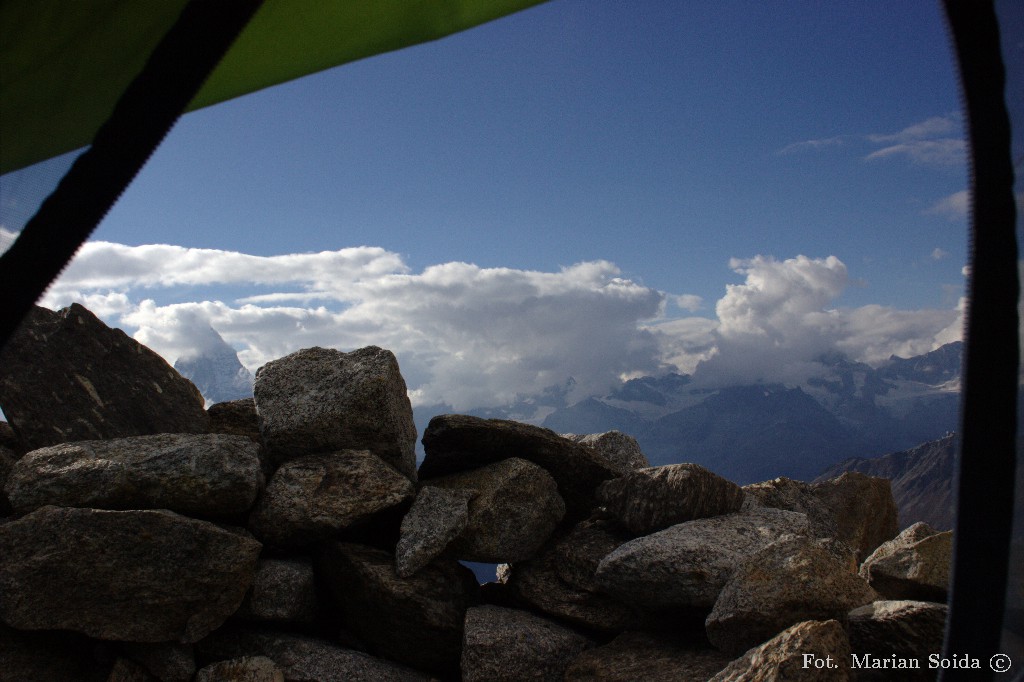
[{"xmin": 237, "ymin": 559, "xmax": 316, "ymax": 624}]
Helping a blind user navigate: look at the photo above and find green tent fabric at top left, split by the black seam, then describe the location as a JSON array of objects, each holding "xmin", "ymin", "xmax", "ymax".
[{"xmin": 0, "ymin": 0, "xmax": 543, "ymax": 173}]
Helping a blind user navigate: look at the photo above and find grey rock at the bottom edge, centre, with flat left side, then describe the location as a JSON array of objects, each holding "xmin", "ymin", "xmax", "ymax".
[{"xmin": 462, "ymin": 605, "xmax": 594, "ymax": 682}]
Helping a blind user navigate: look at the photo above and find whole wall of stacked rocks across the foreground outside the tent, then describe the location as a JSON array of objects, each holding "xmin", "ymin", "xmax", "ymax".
[{"xmin": 0, "ymin": 306, "xmax": 951, "ymax": 682}]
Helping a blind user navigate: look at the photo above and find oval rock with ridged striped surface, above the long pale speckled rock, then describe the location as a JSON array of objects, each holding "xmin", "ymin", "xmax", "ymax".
[{"xmin": 597, "ymin": 464, "xmax": 743, "ymax": 536}]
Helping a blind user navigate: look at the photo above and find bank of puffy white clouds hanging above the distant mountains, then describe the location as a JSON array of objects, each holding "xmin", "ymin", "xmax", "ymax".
[{"xmin": 43, "ymin": 242, "xmax": 962, "ymax": 410}]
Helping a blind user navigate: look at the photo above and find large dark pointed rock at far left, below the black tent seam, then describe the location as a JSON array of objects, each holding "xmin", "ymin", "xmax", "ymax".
[{"xmin": 0, "ymin": 303, "xmax": 208, "ymax": 450}]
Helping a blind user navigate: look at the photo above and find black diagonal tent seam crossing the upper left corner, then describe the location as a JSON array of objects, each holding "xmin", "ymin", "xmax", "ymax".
[{"xmin": 0, "ymin": 0, "xmax": 262, "ymax": 349}]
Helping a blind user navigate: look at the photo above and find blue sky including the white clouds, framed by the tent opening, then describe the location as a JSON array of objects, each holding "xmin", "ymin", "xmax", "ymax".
[{"xmin": 7, "ymin": 0, "xmax": 967, "ymax": 407}]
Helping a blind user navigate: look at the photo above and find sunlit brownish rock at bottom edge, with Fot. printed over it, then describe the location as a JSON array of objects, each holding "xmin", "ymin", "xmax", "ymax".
[{"xmin": 709, "ymin": 621, "xmax": 853, "ymax": 682}]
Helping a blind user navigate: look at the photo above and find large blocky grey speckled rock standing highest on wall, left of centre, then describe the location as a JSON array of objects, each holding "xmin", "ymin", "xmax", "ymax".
[{"xmin": 254, "ymin": 346, "xmax": 416, "ymax": 481}]
